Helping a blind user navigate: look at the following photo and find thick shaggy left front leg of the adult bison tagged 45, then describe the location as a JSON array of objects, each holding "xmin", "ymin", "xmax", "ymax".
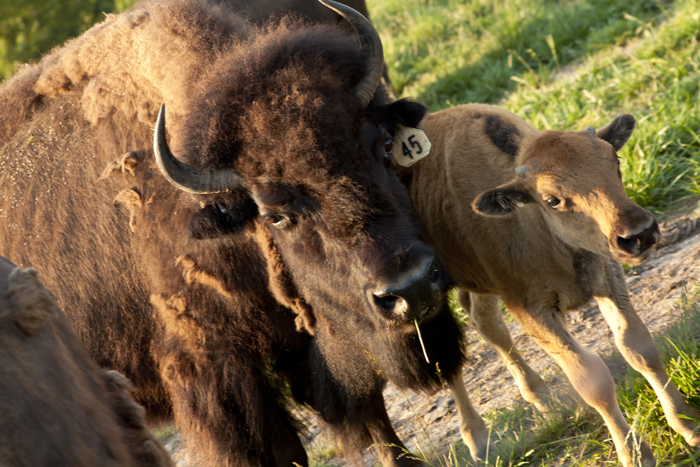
[{"xmin": 163, "ymin": 349, "xmax": 308, "ymax": 467}]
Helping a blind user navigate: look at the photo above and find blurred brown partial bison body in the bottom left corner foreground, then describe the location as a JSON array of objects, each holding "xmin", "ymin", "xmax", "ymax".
[{"xmin": 0, "ymin": 257, "xmax": 172, "ymax": 467}]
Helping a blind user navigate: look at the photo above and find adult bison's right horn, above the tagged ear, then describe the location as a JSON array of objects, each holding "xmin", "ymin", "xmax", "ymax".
[{"xmin": 319, "ymin": 0, "xmax": 384, "ymax": 107}]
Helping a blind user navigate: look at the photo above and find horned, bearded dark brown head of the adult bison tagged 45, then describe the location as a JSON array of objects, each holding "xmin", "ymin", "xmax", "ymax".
[{"xmin": 147, "ymin": 2, "xmax": 461, "ymax": 387}]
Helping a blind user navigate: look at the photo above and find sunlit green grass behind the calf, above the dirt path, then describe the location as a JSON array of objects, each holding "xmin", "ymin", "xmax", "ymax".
[{"xmin": 370, "ymin": 0, "xmax": 700, "ymax": 214}]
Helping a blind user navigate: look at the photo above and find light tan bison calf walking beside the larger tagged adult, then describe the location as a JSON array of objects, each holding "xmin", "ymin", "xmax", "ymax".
[{"xmin": 401, "ymin": 105, "xmax": 700, "ymax": 466}]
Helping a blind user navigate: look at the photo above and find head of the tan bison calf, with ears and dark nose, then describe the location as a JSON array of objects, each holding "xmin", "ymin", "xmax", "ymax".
[{"xmin": 473, "ymin": 115, "xmax": 660, "ymax": 265}]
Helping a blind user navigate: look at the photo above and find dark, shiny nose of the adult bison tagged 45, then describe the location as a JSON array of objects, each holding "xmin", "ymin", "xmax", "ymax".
[{"xmin": 372, "ymin": 257, "xmax": 442, "ymax": 322}]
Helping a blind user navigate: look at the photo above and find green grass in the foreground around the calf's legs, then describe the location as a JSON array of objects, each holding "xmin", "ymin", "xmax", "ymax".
[{"xmin": 400, "ymin": 291, "xmax": 700, "ymax": 467}]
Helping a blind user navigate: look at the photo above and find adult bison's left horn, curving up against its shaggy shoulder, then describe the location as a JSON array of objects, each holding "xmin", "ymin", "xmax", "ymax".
[{"xmin": 153, "ymin": 104, "xmax": 243, "ymax": 195}]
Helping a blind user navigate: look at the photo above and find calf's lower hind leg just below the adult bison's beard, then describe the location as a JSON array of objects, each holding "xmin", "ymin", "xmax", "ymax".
[{"xmin": 447, "ymin": 374, "xmax": 489, "ymax": 461}]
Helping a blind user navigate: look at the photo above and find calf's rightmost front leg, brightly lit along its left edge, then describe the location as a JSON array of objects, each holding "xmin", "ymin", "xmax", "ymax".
[{"xmin": 596, "ymin": 263, "xmax": 700, "ymax": 446}]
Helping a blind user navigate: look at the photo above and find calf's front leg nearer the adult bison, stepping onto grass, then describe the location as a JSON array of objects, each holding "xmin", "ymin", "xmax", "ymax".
[{"xmin": 509, "ymin": 305, "xmax": 656, "ymax": 467}]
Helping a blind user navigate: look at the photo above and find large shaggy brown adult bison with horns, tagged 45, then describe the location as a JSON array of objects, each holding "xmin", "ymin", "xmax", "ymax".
[{"xmin": 0, "ymin": 0, "xmax": 463, "ymax": 466}]
